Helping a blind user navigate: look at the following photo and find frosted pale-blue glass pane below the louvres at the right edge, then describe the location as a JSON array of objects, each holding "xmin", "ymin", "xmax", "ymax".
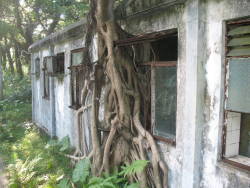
[{"xmin": 226, "ymin": 58, "xmax": 250, "ymax": 113}]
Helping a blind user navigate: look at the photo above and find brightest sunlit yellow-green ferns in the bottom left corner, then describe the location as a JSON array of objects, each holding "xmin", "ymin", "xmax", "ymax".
[{"xmin": 1, "ymin": 129, "xmax": 73, "ymax": 188}]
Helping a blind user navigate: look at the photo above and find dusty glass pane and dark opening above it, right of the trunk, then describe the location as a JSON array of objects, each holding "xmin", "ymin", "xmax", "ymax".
[{"xmin": 151, "ymin": 35, "xmax": 177, "ymax": 140}]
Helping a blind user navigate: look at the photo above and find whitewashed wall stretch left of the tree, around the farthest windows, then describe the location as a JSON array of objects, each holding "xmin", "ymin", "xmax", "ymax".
[{"xmin": 32, "ymin": 38, "xmax": 86, "ymax": 145}]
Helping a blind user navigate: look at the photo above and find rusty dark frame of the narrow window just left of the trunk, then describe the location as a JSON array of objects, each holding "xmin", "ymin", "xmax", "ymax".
[{"xmin": 68, "ymin": 47, "xmax": 85, "ymax": 110}]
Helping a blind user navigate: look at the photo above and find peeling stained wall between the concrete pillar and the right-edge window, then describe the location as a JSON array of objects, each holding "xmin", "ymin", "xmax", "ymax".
[{"xmin": 200, "ymin": 0, "xmax": 250, "ymax": 188}]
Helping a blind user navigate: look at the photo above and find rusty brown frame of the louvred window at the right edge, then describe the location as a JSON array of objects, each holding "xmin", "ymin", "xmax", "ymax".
[{"xmin": 221, "ymin": 18, "xmax": 250, "ymax": 171}]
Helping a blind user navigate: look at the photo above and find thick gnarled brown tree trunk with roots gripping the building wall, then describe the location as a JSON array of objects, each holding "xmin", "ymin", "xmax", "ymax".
[{"xmin": 96, "ymin": 0, "xmax": 167, "ymax": 188}]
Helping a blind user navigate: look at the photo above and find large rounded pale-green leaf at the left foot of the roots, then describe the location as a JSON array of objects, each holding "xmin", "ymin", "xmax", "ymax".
[{"xmin": 72, "ymin": 158, "xmax": 90, "ymax": 183}]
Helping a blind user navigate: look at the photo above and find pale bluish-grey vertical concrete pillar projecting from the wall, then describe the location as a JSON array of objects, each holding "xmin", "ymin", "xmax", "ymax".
[{"xmin": 181, "ymin": 0, "xmax": 205, "ymax": 188}]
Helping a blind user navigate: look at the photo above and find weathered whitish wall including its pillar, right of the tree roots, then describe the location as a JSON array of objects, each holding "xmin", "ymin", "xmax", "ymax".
[{"xmin": 124, "ymin": 0, "xmax": 250, "ymax": 188}]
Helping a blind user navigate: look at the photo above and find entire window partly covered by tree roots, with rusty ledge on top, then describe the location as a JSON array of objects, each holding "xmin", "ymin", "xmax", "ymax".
[{"xmin": 115, "ymin": 29, "xmax": 178, "ymax": 144}]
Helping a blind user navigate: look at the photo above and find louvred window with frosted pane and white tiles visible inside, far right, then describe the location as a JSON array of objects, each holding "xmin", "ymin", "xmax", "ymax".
[{"xmin": 223, "ymin": 19, "xmax": 250, "ymax": 170}]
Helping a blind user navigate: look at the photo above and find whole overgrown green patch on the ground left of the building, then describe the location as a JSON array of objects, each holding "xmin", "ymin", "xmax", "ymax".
[{"xmin": 0, "ymin": 74, "xmax": 72, "ymax": 188}]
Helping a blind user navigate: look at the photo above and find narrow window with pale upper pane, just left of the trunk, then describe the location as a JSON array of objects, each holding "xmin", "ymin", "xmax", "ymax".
[{"xmin": 69, "ymin": 48, "xmax": 84, "ymax": 110}]
